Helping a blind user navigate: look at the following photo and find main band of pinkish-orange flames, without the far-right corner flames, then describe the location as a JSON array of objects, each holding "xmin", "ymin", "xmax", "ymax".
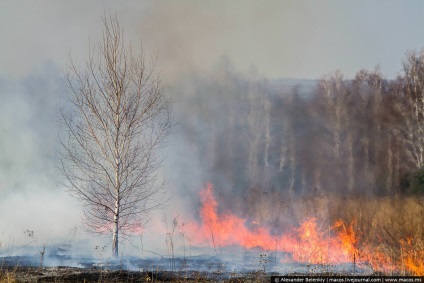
[{"xmin": 187, "ymin": 184, "xmax": 357, "ymax": 263}]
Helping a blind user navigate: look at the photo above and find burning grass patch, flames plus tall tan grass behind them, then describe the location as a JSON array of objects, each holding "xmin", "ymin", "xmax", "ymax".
[{"xmin": 185, "ymin": 184, "xmax": 424, "ymax": 275}]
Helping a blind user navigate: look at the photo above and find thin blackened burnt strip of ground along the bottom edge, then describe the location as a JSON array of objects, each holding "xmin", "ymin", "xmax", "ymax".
[{"xmin": 0, "ymin": 266, "xmax": 271, "ymax": 283}]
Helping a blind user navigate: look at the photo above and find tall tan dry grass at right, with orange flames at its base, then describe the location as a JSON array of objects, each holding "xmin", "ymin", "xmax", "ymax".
[{"xmin": 274, "ymin": 196, "xmax": 424, "ymax": 275}]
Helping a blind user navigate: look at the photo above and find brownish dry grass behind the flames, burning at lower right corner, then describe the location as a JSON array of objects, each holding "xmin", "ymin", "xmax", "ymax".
[{"xmin": 229, "ymin": 190, "xmax": 424, "ymax": 275}]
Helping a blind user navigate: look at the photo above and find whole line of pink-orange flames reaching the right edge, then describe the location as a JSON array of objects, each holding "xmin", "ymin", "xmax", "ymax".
[{"xmin": 186, "ymin": 184, "xmax": 424, "ymax": 275}]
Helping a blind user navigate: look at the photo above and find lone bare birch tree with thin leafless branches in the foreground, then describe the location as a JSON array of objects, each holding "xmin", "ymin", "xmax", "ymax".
[{"xmin": 59, "ymin": 16, "xmax": 172, "ymax": 257}]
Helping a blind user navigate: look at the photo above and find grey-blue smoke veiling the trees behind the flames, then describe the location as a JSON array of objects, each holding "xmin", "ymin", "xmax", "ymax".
[{"xmin": 169, "ymin": 59, "xmax": 419, "ymax": 232}]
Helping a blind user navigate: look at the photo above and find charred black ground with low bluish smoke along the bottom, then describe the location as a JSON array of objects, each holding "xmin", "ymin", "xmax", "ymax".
[{"xmin": 0, "ymin": 250, "xmax": 372, "ymax": 283}]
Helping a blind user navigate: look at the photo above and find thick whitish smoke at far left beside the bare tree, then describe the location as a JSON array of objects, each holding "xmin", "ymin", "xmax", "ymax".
[{"xmin": 0, "ymin": 64, "xmax": 88, "ymax": 247}]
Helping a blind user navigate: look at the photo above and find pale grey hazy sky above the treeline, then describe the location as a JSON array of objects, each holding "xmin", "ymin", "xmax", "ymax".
[{"xmin": 0, "ymin": 0, "xmax": 424, "ymax": 81}]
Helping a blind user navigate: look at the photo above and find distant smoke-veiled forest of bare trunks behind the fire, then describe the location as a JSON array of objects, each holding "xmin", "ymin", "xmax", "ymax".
[{"xmin": 174, "ymin": 52, "xmax": 424, "ymax": 211}]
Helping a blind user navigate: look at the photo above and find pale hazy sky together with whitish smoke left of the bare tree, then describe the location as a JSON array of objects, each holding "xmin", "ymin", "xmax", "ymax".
[{"xmin": 0, "ymin": 0, "xmax": 424, "ymax": 251}]
